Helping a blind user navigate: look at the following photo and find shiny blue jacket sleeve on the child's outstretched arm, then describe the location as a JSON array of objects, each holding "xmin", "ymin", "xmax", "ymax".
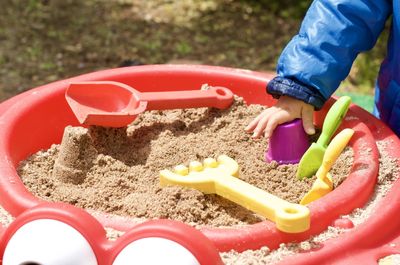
[{"xmin": 267, "ymin": 0, "xmax": 392, "ymax": 109}]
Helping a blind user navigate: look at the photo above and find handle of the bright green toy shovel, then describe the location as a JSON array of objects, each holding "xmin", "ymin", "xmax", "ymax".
[{"xmin": 317, "ymin": 96, "xmax": 351, "ymax": 147}]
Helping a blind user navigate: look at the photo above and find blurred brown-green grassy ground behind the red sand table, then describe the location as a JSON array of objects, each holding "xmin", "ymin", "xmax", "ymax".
[{"xmin": 0, "ymin": 0, "xmax": 385, "ymax": 104}]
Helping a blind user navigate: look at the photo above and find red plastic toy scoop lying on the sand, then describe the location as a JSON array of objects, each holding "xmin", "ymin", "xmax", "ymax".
[{"xmin": 65, "ymin": 81, "xmax": 233, "ymax": 127}]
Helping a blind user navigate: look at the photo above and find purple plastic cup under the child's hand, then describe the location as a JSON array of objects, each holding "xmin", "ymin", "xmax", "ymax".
[{"xmin": 265, "ymin": 119, "xmax": 310, "ymax": 164}]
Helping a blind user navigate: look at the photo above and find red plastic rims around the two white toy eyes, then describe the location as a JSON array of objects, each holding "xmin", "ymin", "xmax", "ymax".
[{"xmin": 0, "ymin": 202, "xmax": 223, "ymax": 265}]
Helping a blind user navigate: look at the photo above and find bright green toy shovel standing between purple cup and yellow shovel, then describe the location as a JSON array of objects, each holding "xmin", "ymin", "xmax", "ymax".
[{"xmin": 296, "ymin": 96, "xmax": 351, "ymax": 179}]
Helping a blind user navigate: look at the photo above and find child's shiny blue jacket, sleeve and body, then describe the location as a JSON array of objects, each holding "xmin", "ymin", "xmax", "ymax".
[{"xmin": 268, "ymin": 0, "xmax": 400, "ymax": 136}]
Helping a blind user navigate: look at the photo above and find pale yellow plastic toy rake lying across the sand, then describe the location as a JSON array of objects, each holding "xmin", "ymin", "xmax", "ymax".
[{"xmin": 160, "ymin": 155, "xmax": 310, "ymax": 233}]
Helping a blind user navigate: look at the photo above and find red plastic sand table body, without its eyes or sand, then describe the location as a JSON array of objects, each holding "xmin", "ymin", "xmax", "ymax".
[{"xmin": 0, "ymin": 65, "xmax": 400, "ymax": 264}]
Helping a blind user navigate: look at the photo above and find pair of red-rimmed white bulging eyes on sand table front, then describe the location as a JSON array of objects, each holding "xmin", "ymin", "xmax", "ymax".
[{"xmin": 0, "ymin": 203, "xmax": 223, "ymax": 265}]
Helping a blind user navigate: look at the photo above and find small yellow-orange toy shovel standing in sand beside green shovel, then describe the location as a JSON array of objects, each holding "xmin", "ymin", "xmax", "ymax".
[{"xmin": 300, "ymin": 129, "xmax": 354, "ymax": 205}]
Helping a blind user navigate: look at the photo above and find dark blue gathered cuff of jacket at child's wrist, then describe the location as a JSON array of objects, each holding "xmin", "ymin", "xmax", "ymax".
[{"xmin": 267, "ymin": 76, "xmax": 326, "ymax": 110}]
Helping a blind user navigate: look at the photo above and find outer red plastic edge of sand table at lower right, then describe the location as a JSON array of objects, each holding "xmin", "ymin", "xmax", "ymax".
[{"xmin": 279, "ymin": 102, "xmax": 400, "ymax": 265}]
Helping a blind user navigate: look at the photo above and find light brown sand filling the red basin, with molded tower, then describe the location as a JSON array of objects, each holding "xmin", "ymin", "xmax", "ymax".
[{"xmin": 18, "ymin": 97, "xmax": 352, "ymax": 227}]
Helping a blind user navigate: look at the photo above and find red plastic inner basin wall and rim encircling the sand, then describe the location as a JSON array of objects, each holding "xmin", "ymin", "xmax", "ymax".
[{"xmin": 0, "ymin": 65, "xmax": 382, "ymax": 251}]
